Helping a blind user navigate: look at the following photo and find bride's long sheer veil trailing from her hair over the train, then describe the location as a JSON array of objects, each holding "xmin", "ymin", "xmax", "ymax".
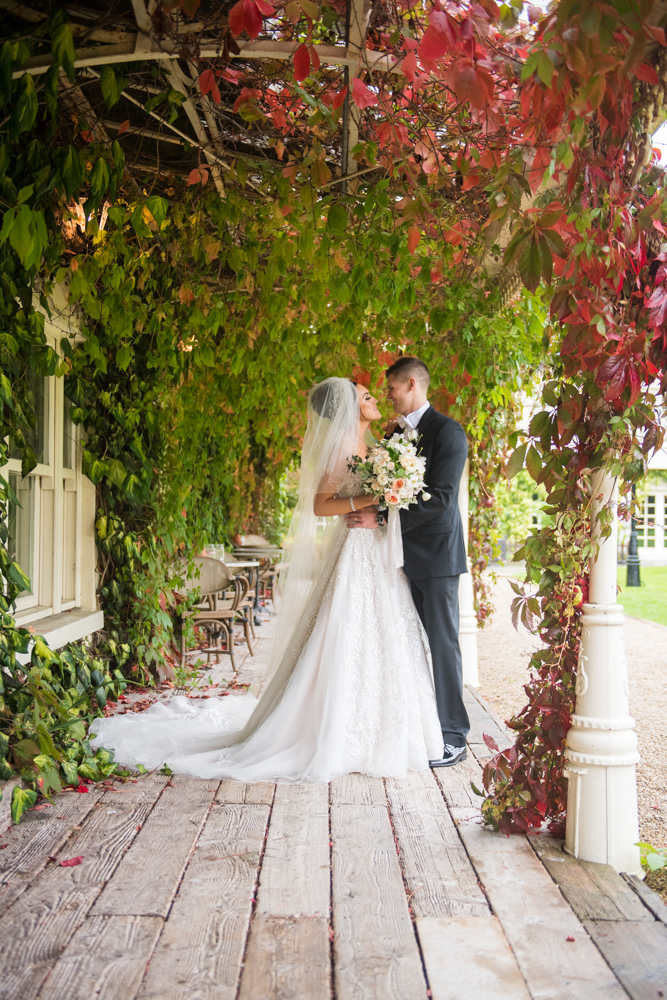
[{"xmin": 90, "ymin": 378, "xmax": 360, "ymax": 766}]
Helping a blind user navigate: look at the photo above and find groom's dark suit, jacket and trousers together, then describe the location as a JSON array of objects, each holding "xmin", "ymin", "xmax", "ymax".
[{"xmin": 388, "ymin": 406, "xmax": 470, "ymax": 746}]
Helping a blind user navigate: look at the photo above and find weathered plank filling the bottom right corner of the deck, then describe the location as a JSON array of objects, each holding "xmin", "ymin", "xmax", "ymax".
[{"xmin": 585, "ymin": 920, "xmax": 667, "ymax": 1000}]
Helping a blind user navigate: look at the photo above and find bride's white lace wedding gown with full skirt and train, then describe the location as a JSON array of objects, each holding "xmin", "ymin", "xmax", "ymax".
[{"xmin": 91, "ymin": 464, "xmax": 443, "ymax": 782}]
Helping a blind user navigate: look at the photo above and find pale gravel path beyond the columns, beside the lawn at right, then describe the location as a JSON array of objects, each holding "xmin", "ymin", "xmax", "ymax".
[{"xmin": 478, "ymin": 578, "xmax": 667, "ymax": 847}]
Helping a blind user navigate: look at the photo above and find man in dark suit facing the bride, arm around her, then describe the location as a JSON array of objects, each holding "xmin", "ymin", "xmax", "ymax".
[{"xmin": 348, "ymin": 358, "xmax": 470, "ymax": 767}]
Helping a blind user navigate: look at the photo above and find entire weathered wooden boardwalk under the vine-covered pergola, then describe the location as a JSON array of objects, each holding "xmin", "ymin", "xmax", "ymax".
[{"xmin": 0, "ymin": 624, "xmax": 667, "ymax": 1000}]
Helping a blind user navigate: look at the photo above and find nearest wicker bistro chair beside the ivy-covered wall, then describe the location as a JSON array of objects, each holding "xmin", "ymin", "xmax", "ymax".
[{"xmin": 181, "ymin": 556, "xmax": 254, "ymax": 672}]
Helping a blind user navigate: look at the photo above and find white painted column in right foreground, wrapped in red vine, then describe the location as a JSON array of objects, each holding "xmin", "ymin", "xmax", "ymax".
[{"xmin": 565, "ymin": 471, "xmax": 641, "ymax": 874}]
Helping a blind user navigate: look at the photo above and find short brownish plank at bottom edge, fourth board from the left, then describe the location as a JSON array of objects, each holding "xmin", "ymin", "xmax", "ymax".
[{"xmin": 239, "ymin": 916, "xmax": 331, "ymax": 1000}]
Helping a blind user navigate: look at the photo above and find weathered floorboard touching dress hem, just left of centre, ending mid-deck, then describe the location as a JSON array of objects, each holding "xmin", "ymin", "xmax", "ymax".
[{"xmin": 257, "ymin": 784, "xmax": 330, "ymax": 916}]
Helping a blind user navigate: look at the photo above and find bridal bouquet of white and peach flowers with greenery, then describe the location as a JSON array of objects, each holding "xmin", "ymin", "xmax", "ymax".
[{"xmin": 348, "ymin": 431, "xmax": 431, "ymax": 510}]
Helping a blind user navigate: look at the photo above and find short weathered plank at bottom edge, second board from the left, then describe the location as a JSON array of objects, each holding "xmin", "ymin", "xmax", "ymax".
[{"xmin": 39, "ymin": 916, "xmax": 164, "ymax": 1000}]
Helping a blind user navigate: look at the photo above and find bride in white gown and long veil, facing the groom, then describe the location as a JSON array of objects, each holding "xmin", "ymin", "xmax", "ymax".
[{"xmin": 90, "ymin": 378, "xmax": 443, "ymax": 782}]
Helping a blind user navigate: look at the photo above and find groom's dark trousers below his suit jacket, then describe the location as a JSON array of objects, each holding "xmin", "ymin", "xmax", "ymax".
[{"xmin": 410, "ymin": 576, "xmax": 470, "ymax": 747}]
